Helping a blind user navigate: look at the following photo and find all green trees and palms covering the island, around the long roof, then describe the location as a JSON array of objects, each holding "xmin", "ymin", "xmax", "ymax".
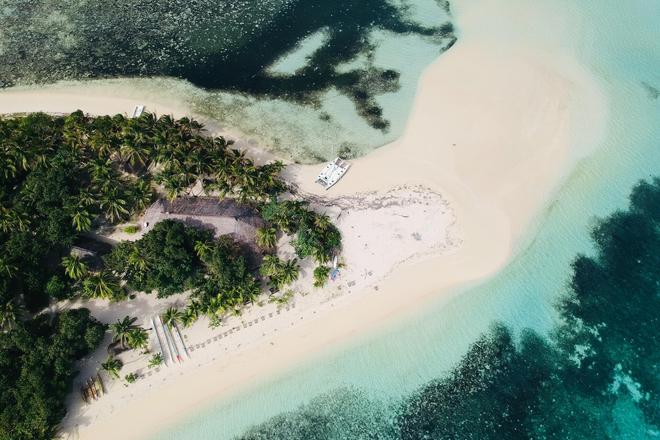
[{"xmin": 0, "ymin": 111, "xmax": 341, "ymax": 439}]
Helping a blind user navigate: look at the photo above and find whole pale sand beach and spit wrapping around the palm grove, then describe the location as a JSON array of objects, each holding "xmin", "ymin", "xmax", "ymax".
[{"xmin": 0, "ymin": 1, "xmax": 608, "ymax": 439}]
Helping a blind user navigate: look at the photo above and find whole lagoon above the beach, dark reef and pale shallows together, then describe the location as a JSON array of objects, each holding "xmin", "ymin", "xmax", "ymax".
[{"xmin": 0, "ymin": 0, "xmax": 455, "ymax": 162}]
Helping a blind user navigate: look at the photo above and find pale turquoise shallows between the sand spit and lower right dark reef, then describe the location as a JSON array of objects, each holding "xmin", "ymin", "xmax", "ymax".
[{"xmin": 157, "ymin": 0, "xmax": 660, "ymax": 439}]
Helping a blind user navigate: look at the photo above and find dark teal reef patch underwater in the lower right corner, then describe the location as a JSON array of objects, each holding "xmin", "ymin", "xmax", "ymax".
[{"xmin": 241, "ymin": 179, "xmax": 660, "ymax": 440}]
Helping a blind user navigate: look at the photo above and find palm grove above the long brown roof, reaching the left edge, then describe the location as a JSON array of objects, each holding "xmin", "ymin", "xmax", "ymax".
[{"xmin": 0, "ymin": 112, "xmax": 285, "ymax": 310}]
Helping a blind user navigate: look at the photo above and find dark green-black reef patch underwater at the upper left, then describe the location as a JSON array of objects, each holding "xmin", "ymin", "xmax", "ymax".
[{"xmin": 0, "ymin": 0, "xmax": 455, "ymax": 130}]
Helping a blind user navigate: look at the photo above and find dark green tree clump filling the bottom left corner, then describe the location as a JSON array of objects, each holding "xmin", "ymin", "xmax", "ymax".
[{"xmin": 0, "ymin": 309, "xmax": 106, "ymax": 440}]
